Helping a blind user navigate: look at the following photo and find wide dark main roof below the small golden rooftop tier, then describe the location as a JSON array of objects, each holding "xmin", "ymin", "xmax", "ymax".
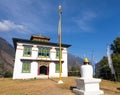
[{"xmin": 13, "ymin": 38, "xmax": 71, "ymax": 49}]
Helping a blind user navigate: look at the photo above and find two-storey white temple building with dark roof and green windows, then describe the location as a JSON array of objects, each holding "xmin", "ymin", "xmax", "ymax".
[{"xmin": 13, "ymin": 36, "xmax": 70, "ymax": 79}]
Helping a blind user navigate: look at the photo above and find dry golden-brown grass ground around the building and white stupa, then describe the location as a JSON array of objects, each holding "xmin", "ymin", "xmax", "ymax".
[{"xmin": 0, "ymin": 77, "xmax": 120, "ymax": 95}]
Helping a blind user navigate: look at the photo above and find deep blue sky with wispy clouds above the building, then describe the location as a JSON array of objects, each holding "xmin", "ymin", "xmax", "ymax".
[{"xmin": 0, "ymin": 0, "xmax": 120, "ymax": 62}]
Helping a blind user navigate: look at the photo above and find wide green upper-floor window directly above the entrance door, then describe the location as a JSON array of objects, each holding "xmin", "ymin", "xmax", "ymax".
[{"xmin": 38, "ymin": 47, "xmax": 50, "ymax": 58}]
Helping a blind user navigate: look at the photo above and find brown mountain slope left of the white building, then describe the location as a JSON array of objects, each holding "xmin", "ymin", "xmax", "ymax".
[{"xmin": 0, "ymin": 38, "xmax": 15, "ymax": 75}]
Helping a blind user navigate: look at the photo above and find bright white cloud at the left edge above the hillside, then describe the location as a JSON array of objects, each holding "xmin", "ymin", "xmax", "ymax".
[{"xmin": 0, "ymin": 20, "xmax": 26, "ymax": 32}]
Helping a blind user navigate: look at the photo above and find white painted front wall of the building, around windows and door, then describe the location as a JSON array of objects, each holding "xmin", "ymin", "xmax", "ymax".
[{"xmin": 13, "ymin": 43, "xmax": 68, "ymax": 79}]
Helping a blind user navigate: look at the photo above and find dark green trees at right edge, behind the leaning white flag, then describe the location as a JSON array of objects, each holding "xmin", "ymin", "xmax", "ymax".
[{"xmin": 96, "ymin": 37, "xmax": 120, "ymax": 81}]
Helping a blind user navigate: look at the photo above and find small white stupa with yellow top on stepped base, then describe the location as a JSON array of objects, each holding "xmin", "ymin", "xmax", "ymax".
[{"xmin": 73, "ymin": 58, "xmax": 104, "ymax": 95}]
